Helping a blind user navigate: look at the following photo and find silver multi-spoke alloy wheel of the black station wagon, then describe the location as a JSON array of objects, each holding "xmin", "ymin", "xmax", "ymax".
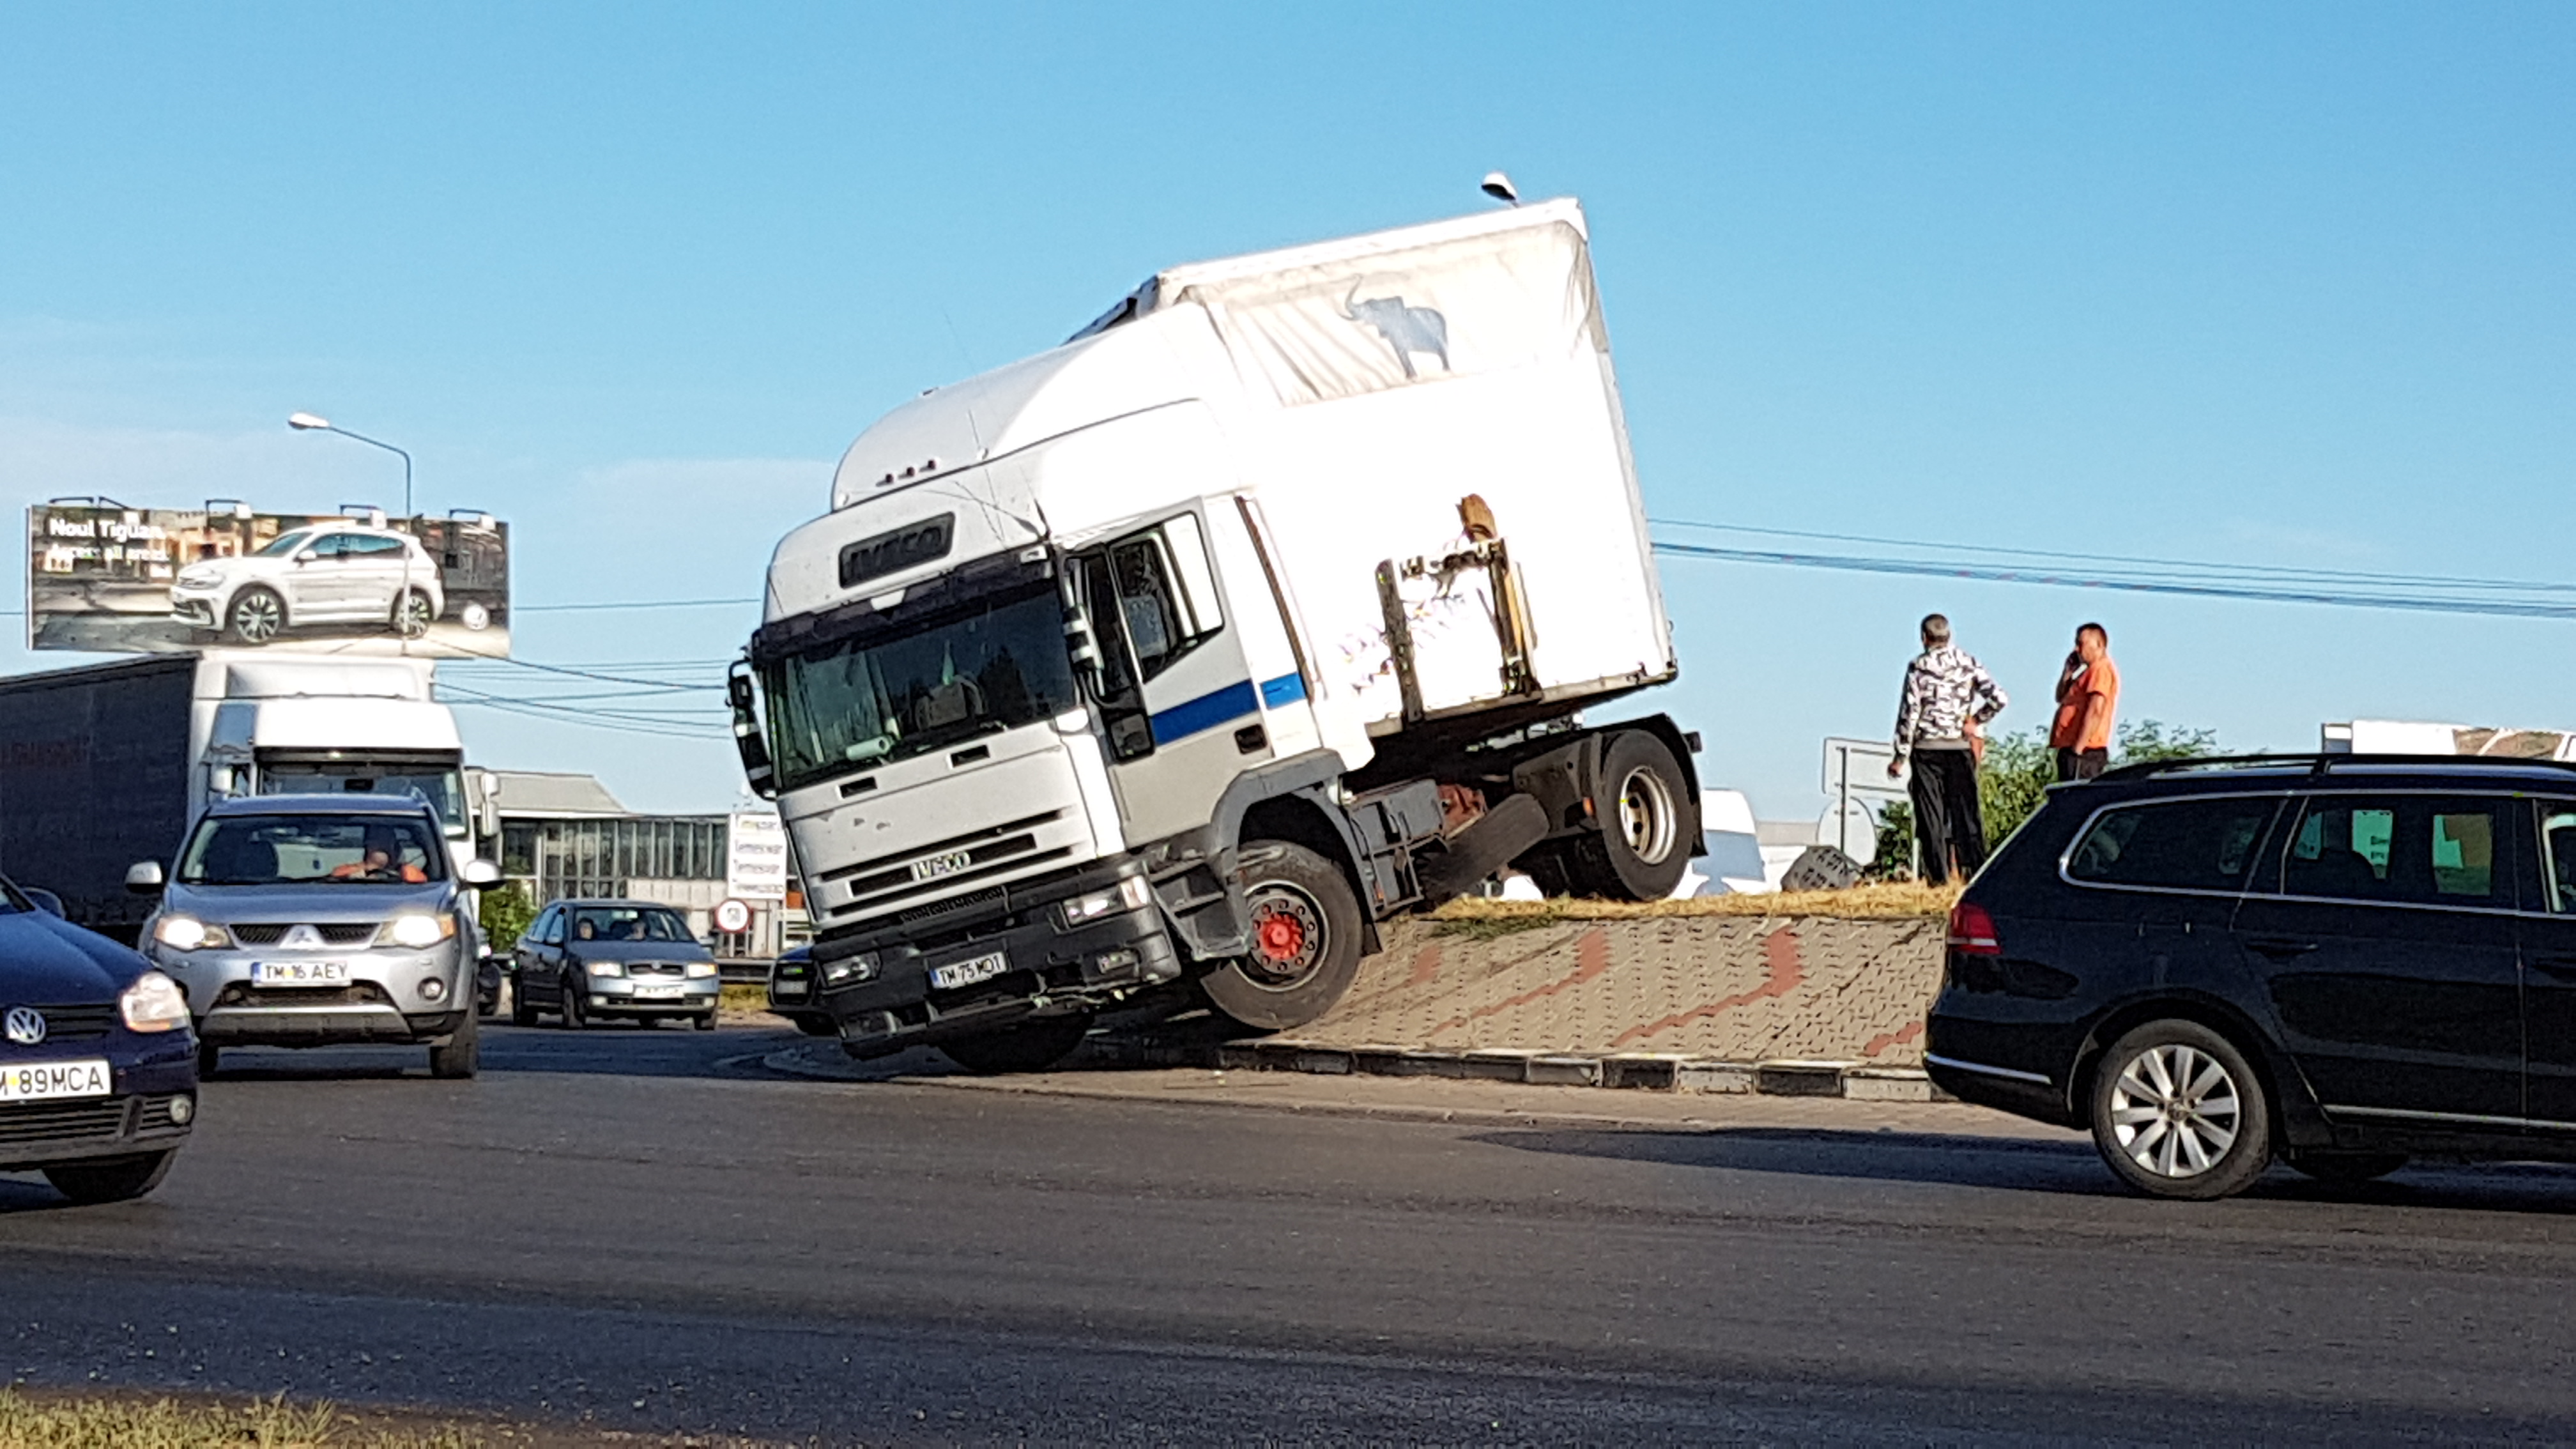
[{"xmin": 2092, "ymin": 1021, "xmax": 2272, "ymax": 1199}]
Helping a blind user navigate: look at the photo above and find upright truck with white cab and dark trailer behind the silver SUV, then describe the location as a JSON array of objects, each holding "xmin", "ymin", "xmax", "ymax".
[{"xmin": 0, "ymin": 652, "xmax": 494, "ymax": 941}]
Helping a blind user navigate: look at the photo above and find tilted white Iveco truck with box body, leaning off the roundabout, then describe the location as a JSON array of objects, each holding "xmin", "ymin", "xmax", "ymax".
[{"xmin": 732, "ymin": 201, "xmax": 1700, "ymax": 1070}]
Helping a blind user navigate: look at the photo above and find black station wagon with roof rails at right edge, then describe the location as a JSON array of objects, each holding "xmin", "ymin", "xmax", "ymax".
[{"xmin": 1924, "ymin": 755, "xmax": 2576, "ymax": 1199}]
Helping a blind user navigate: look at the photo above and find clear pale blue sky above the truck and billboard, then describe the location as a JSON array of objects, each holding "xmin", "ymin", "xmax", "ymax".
[{"xmin": 0, "ymin": 5, "xmax": 2576, "ymax": 817}]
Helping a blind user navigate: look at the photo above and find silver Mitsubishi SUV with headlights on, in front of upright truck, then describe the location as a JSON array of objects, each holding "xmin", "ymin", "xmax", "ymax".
[{"xmin": 126, "ymin": 794, "xmax": 497, "ymax": 1078}]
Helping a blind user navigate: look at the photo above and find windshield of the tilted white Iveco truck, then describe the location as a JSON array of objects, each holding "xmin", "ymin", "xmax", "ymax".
[{"xmin": 762, "ymin": 580, "xmax": 1079, "ymax": 789}]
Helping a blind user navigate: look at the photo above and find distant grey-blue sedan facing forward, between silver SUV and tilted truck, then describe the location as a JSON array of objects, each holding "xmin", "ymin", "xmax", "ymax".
[{"xmin": 510, "ymin": 900, "xmax": 724, "ymax": 1031}]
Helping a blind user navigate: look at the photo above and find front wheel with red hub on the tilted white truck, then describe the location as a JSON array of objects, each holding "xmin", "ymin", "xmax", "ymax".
[{"xmin": 1200, "ymin": 841, "xmax": 1360, "ymax": 1031}]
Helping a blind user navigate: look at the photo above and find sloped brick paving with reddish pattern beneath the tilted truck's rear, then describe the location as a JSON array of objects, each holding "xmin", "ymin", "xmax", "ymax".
[{"xmin": 1293, "ymin": 916, "xmax": 1942, "ymax": 1068}]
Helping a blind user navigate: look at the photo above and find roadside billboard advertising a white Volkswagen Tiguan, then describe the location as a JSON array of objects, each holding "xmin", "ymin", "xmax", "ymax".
[{"xmin": 26, "ymin": 503, "xmax": 510, "ymax": 657}]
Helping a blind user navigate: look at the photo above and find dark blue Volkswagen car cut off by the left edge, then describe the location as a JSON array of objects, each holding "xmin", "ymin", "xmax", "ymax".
[{"xmin": 0, "ymin": 879, "xmax": 195, "ymax": 1204}]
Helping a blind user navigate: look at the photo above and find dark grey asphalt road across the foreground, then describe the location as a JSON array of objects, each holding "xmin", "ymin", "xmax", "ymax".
[{"xmin": 0, "ymin": 1029, "xmax": 2576, "ymax": 1444}]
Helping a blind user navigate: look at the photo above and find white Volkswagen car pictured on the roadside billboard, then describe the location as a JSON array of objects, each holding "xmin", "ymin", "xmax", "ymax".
[{"xmin": 170, "ymin": 523, "xmax": 446, "ymax": 645}]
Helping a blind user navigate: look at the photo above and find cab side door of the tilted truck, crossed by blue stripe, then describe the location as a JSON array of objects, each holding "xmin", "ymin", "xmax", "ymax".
[{"xmin": 1077, "ymin": 510, "xmax": 1267, "ymax": 846}]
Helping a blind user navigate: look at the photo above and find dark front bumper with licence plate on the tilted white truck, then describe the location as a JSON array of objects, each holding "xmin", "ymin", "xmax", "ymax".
[{"xmin": 814, "ymin": 866, "xmax": 1180, "ymax": 1057}]
